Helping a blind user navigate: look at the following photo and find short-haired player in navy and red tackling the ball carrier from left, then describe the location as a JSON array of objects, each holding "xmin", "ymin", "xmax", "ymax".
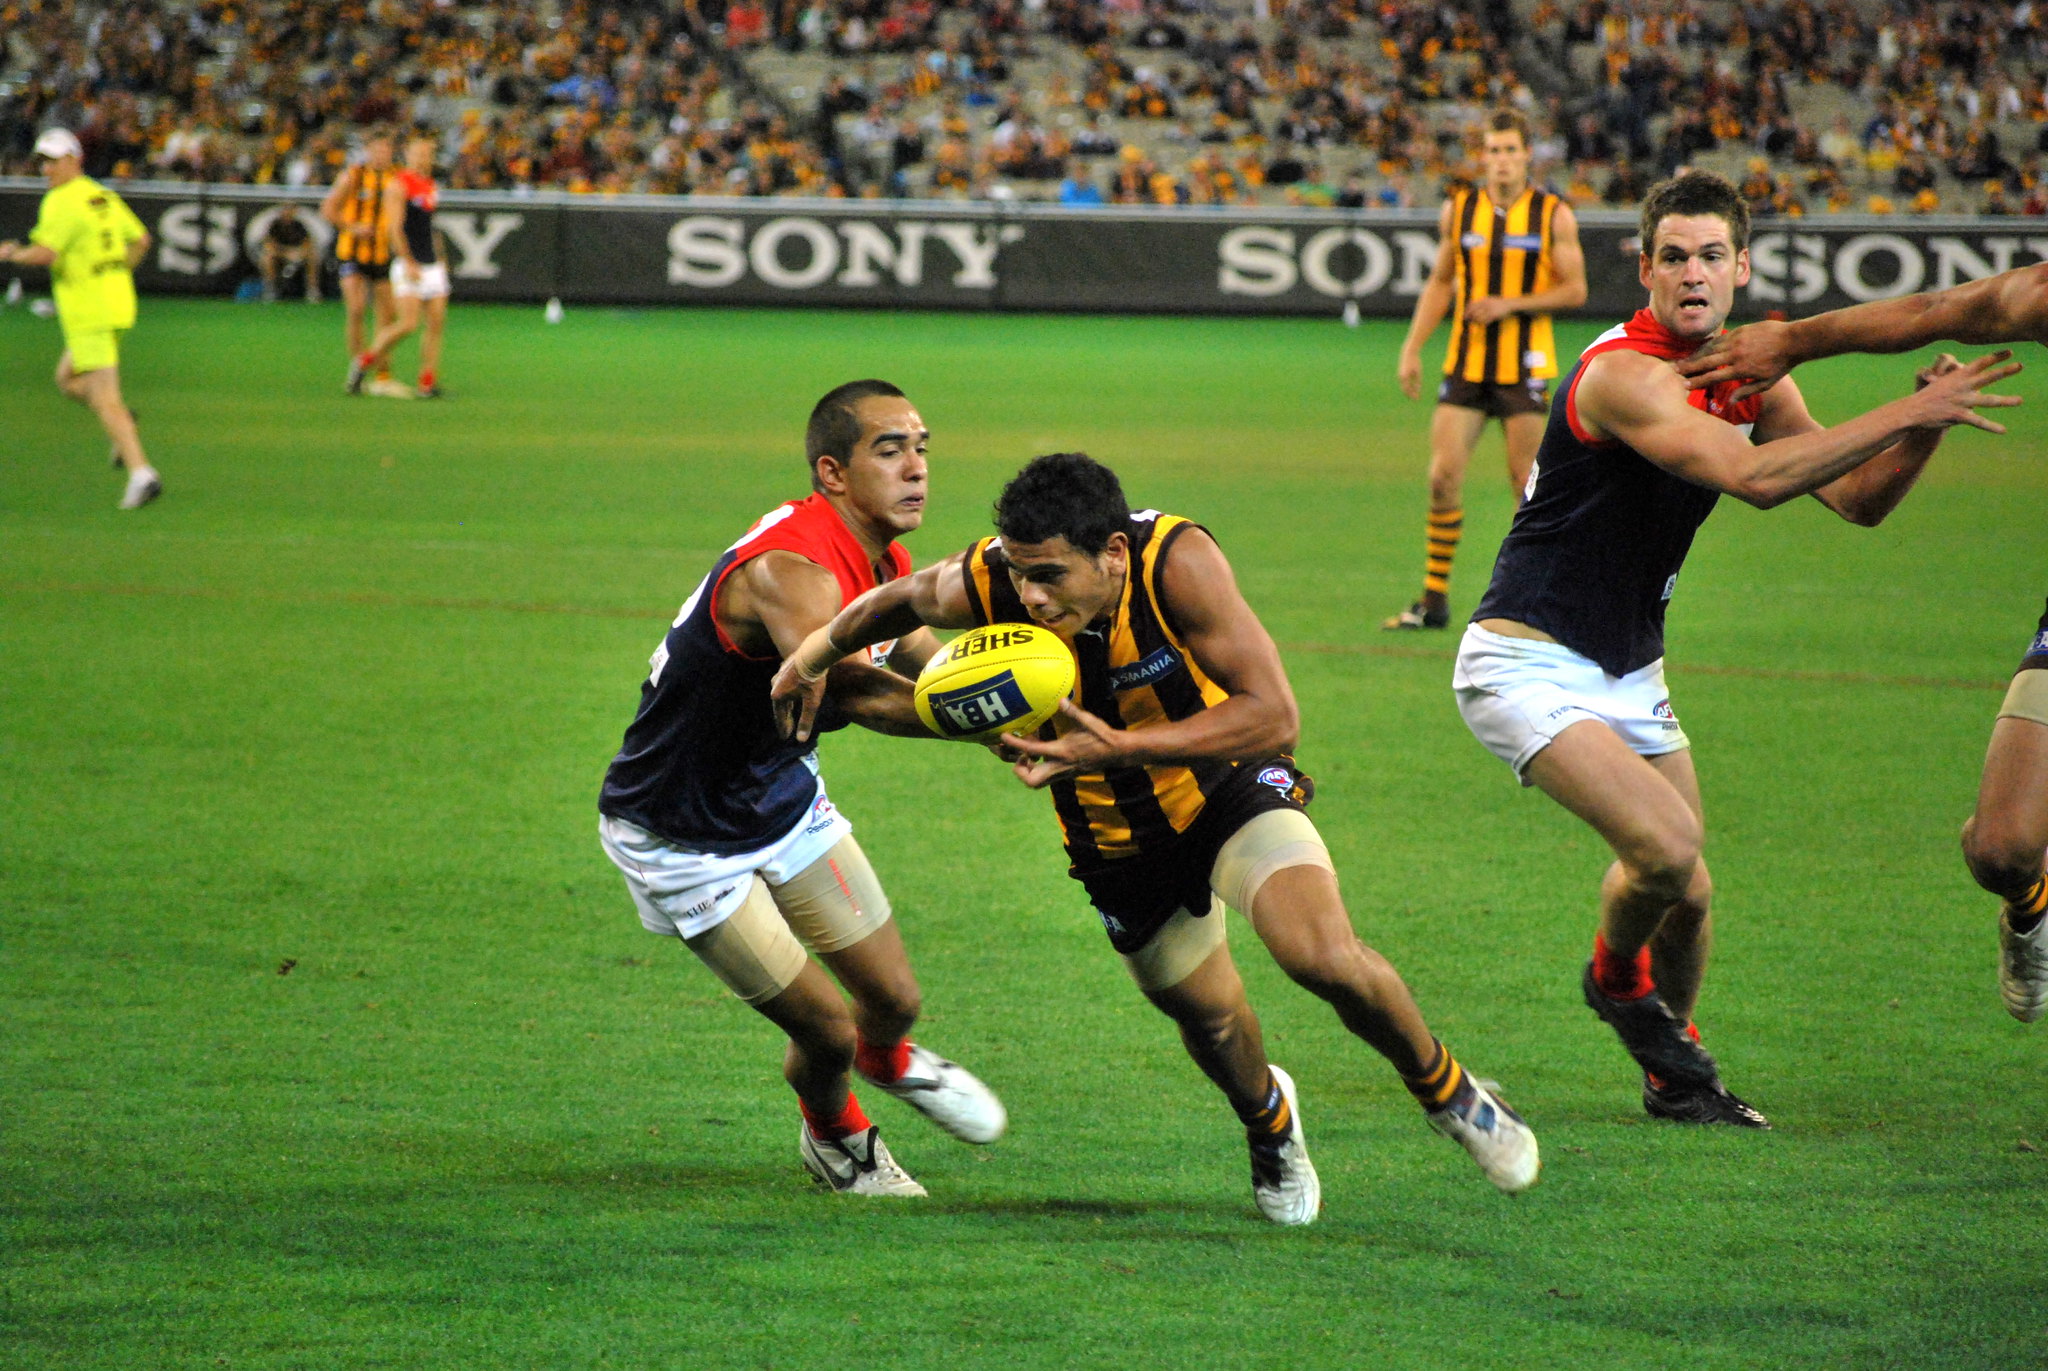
[{"xmin": 598, "ymin": 381, "xmax": 1006, "ymax": 1195}]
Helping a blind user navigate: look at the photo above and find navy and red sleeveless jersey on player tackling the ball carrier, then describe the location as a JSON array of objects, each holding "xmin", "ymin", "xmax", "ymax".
[{"xmin": 598, "ymin": 496, "xmax": 909, "ymax": 855}]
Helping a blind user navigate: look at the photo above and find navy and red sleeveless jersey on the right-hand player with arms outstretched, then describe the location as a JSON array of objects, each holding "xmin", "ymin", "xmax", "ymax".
[{"xmin": 1473, "ymin": 309, "xmax": 1763, "ymax": 676}]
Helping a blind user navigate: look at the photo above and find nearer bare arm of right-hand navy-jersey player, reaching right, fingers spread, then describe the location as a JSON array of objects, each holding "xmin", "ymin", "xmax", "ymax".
[{"xmin": 1577, "ymin": 352, "xmax": 2019, "ymax": 508}]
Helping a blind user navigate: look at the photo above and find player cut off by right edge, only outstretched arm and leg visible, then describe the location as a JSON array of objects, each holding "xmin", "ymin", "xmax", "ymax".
[{"xmin": 1679, "ymin": 262, "xmax": 2048, "ymax": 1023}]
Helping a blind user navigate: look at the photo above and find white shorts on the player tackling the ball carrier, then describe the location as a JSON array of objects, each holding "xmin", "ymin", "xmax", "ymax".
[{"xmin": 598, "ymin": 781, "xmax": 854, "ymax": 939}]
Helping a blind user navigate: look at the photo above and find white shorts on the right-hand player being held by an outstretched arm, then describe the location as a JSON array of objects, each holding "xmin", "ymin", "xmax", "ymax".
[{"xmin": 1450, "ymin": 623, "xmax": 1692, "ymax": 785}]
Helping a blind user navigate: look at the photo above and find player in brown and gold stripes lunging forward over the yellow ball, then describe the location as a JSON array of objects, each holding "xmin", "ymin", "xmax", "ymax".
[{"xmin": 774, "ymin": 453, "xmax": 1538, "ymax": 1223}]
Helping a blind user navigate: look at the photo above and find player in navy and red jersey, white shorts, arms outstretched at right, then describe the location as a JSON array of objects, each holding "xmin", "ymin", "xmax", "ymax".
[{"xmin": 1452, "ymin": 172, "xmax": 2019, "ymax": 1127}]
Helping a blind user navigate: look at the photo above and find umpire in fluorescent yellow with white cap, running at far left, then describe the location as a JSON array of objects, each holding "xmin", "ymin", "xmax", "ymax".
[{"xmin": 0, "ymin": 129, "xmax": 164, "ymax": 510}]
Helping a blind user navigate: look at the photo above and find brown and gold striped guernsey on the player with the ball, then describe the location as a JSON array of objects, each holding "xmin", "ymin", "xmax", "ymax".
[{"xmin": 963, "ymin": 510, "xmax": 1237, "ymax": 871}]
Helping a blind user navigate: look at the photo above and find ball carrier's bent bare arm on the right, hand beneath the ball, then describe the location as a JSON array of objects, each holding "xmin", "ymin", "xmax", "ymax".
[{"xmin": 1004, "ymin": 529, "xmax": 1300, "ymax": 785}]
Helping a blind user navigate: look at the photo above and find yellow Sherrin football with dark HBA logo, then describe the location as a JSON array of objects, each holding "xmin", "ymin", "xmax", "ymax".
[{"xmin": 918, "ymin": 623, "xmax": 1075, "ymax": 742}]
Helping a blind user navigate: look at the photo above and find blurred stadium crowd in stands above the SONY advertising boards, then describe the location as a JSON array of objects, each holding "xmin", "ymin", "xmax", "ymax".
[{"xmin": 0, "ymin": 0, "xmax": 2048, "ymax": 215}]
